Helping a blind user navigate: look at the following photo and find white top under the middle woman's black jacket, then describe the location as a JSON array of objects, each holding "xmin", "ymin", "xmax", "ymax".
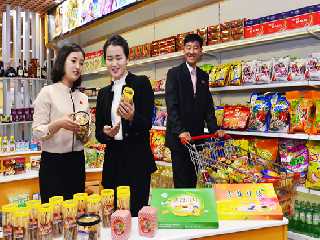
[{"xmin": 111, "ymin": 73, "xmax": 128, "ymax": 140}]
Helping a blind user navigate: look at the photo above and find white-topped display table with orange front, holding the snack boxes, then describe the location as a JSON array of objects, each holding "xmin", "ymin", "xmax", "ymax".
[{"xmin": 60, "ymin": 218, "xmax": 288, "ymax": 240}]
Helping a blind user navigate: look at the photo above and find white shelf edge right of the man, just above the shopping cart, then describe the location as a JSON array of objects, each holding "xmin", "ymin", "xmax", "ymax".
[{"xmin": 225, "ymin": 130, "xmax": 309, "ymax": 140}]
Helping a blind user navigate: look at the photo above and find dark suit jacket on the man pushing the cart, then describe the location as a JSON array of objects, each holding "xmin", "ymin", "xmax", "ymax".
[{"xmin": 165, "ymin": 63, "xmax": 218, "ymax": 149}]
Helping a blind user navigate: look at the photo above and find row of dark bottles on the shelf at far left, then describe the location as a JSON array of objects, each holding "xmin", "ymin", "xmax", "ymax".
[{"xmin": 0, "ymin": 58, "xmax": 47, "ymax": 79}]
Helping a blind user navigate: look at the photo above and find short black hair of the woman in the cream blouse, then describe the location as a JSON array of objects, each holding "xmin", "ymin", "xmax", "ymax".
[{"xmin": 51, "ymin": 43, "xmax": 85, "ymax": 91}]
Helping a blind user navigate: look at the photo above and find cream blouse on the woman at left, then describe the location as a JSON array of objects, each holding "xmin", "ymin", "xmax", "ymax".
[{"xmin": 32, "ymin": 82, "xmax": 89, "ymax": 153}]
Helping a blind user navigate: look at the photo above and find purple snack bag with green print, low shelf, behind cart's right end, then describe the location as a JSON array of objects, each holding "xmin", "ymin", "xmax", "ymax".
[{"xmin": 279, "ymin": 139, "xmax": 309, "ymax": 183}]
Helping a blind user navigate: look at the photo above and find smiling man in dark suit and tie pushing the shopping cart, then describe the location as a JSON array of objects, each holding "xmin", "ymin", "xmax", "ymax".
[{"xmin": 165, "ymin": 34, "xmax": 222, "ymax": 188}]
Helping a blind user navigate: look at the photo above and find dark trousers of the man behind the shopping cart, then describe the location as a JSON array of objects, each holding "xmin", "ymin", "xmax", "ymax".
[{"xmin": 170, "ymin": 146, "xmax": 197, "ymax": 188}]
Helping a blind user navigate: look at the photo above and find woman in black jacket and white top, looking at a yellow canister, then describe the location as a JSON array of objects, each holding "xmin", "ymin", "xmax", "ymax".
[{"xmin": 96, "ymin": 35, "xmax": 156, "ymax": 216}]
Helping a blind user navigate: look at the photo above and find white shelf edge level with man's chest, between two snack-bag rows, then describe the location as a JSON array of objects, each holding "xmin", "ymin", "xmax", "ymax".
[{"xmin": 210, "ymin": 81, "xmax": 312, "ymax": 92}]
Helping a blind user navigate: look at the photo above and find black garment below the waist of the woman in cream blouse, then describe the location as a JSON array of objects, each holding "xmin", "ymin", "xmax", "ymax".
[{"xmin": 39, "ymin": 151, "xmax": 86, "ymax": 203}]
